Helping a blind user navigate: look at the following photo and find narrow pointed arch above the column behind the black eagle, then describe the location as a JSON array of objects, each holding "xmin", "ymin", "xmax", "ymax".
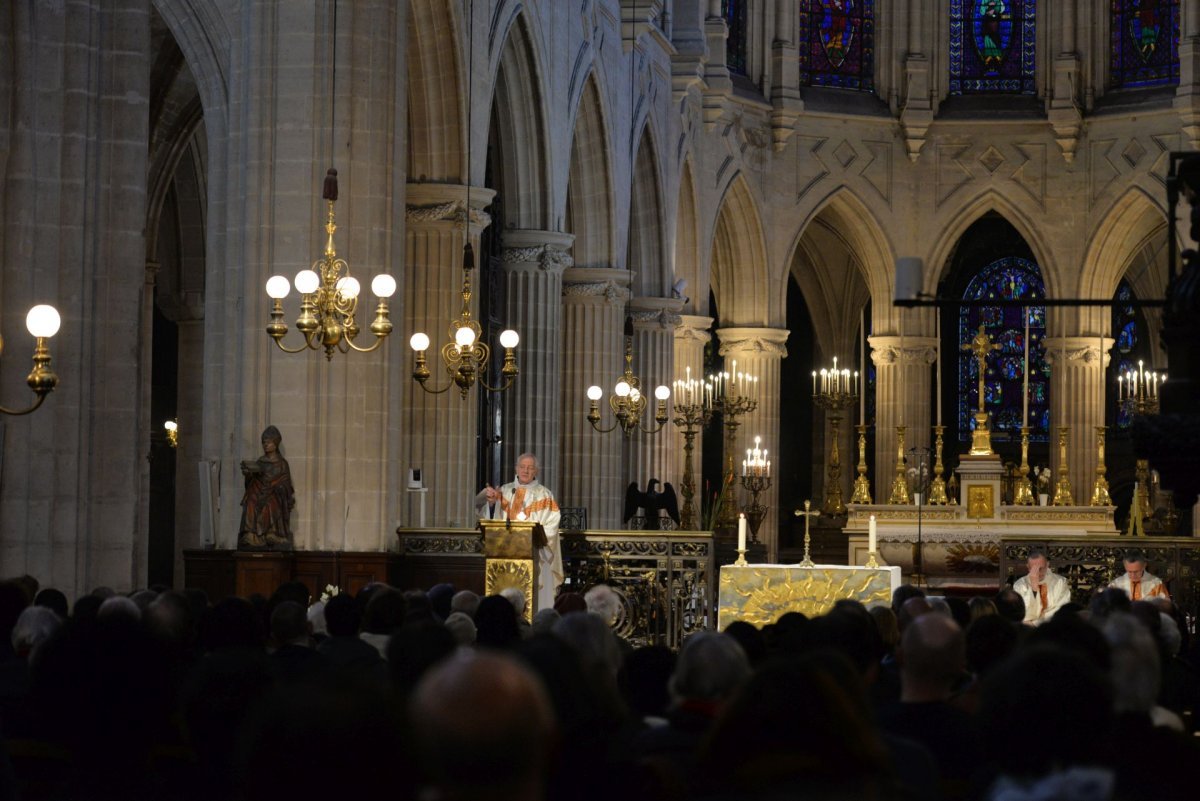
[{"xmin": 629, "ymin": 126, "xmax": 672, "ymax": 291}]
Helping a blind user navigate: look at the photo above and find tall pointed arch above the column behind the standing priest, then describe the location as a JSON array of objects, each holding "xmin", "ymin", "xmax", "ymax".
[{"xmin": 484, "ymin": 12, "xmax": 551, "ymax": 230}]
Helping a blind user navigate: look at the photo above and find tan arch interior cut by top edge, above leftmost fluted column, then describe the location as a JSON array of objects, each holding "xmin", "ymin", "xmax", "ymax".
[{"xmin": 407, "ymin": 0, "xmax": 469, "ymax": 183}]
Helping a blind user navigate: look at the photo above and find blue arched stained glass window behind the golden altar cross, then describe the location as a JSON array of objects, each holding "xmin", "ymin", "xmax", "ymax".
[{"xmin": 958, "ymin": 257, "xmax": 1050, "ymax": 442}]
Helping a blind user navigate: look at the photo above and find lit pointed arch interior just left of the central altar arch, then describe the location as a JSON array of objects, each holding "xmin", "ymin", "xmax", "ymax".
[{"xmin": 779, "ymin": 186, "xmax": 895, "ymax": 338}]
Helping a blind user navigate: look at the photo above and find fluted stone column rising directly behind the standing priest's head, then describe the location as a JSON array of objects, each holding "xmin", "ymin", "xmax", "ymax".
[{"xmin": 502, "ymin": 229, "xmax": 575, "ymax": 489}]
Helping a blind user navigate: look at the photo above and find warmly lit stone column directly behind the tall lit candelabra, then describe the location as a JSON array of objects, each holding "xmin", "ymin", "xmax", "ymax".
[{"xmin": 713, "ymin": 329, "xmax": 788, "ymax": 561}]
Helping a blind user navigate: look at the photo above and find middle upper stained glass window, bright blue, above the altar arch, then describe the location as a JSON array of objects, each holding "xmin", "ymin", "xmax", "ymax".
[{"xmin": 950, "ymin": 0, "xmax": 1037, "ymax": 95}]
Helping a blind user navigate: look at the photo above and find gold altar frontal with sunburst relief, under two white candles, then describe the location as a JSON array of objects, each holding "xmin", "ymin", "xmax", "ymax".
[{"xmin": 716, "ymin": 565, "xmax": 900, "ymax": 631}]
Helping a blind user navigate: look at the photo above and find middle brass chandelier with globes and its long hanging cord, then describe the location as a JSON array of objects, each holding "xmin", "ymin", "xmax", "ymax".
[{"xmin": 408, "ymin": 1, "xmax": 521, "ymax": 399}]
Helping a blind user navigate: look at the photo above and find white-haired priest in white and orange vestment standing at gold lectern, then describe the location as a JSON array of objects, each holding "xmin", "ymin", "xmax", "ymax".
[{"xmin": 475, "ymin": 453, "xmax": 563, "ymax": 612}]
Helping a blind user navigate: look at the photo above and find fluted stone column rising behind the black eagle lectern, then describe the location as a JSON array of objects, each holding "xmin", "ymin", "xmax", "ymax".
[{"xmin": 625, "ymin": 297, "xmax": 683, "ymax": 492}]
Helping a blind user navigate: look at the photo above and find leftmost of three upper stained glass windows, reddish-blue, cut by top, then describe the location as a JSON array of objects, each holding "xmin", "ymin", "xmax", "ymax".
[{"xmin": 797, "ymin": 0, "xmax": 875, "ymax": 91}]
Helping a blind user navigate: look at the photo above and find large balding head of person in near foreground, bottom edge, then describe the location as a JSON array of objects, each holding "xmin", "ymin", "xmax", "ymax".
[{"xmin": 412, "ymin": 651, "xmax": 554, "ymax": 801}]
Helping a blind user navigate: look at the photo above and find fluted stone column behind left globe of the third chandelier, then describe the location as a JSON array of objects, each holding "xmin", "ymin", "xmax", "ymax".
[{"xmin": 554, "ymin": 267, "xmax": 630, "ymax": 529}]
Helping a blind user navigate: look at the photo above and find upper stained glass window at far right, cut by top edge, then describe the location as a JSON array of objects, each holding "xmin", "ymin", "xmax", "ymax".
[{"xmin": 1109, "ymin": 0, "xmax": 1180, "ymax": 89}]
